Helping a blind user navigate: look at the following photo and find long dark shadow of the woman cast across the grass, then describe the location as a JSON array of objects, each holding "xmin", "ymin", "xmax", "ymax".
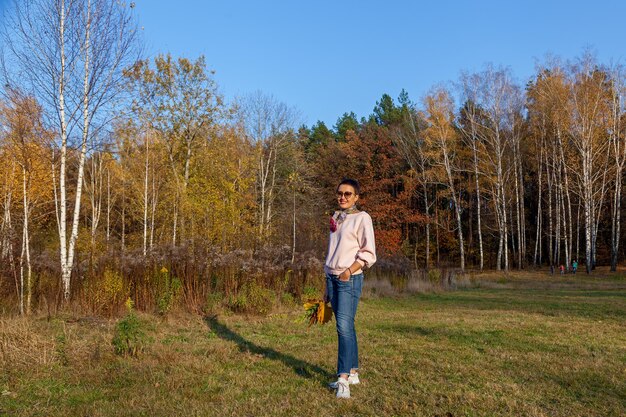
[{"xmin": 204, "ymin": 316, "xmax": 335, "ymax": 385}]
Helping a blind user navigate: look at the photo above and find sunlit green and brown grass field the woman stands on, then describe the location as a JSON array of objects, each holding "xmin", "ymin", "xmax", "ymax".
[{"xmin": 0, "ymin": 273, "xmax": 626, "ymax": 417}]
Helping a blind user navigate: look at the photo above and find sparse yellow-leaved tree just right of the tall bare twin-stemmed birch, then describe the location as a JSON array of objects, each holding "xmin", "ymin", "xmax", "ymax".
[{"xmin": 126, "ymin": 54, "xmax": 223, "ymax": 245}]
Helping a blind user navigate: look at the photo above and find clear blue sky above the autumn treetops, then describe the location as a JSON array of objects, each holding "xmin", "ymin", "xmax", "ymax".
[{"xmin": 0, "ymin": 0, "xmax": 626, "ymax": 126}]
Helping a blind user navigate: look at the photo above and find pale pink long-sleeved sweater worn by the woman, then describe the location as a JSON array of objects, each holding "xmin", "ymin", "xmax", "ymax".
[{"xmin": 324, "ymin": 211, "xmax": 376, "ymax": 275}]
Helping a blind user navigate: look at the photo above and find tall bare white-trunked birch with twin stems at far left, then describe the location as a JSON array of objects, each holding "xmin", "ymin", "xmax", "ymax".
[{"xmin": 4, "ymin": 0, "xmax": 138, "ymax": 300}]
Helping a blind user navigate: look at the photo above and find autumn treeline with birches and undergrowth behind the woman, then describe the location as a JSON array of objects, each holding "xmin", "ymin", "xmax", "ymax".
[{"xmin": 0, "ymin": 0, "xmax": 626, "ymax": 313}]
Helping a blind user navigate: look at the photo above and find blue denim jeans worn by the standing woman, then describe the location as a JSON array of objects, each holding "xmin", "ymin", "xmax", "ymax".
[{"xmin": 326, "ymin": 274, "xmax": 363, "ymax": 375}]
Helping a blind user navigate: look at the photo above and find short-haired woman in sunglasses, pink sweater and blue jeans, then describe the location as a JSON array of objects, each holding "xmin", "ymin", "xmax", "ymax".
[{"xmin": 324, "ymin": 179, "xmax": 376, "ymax": 398}]
